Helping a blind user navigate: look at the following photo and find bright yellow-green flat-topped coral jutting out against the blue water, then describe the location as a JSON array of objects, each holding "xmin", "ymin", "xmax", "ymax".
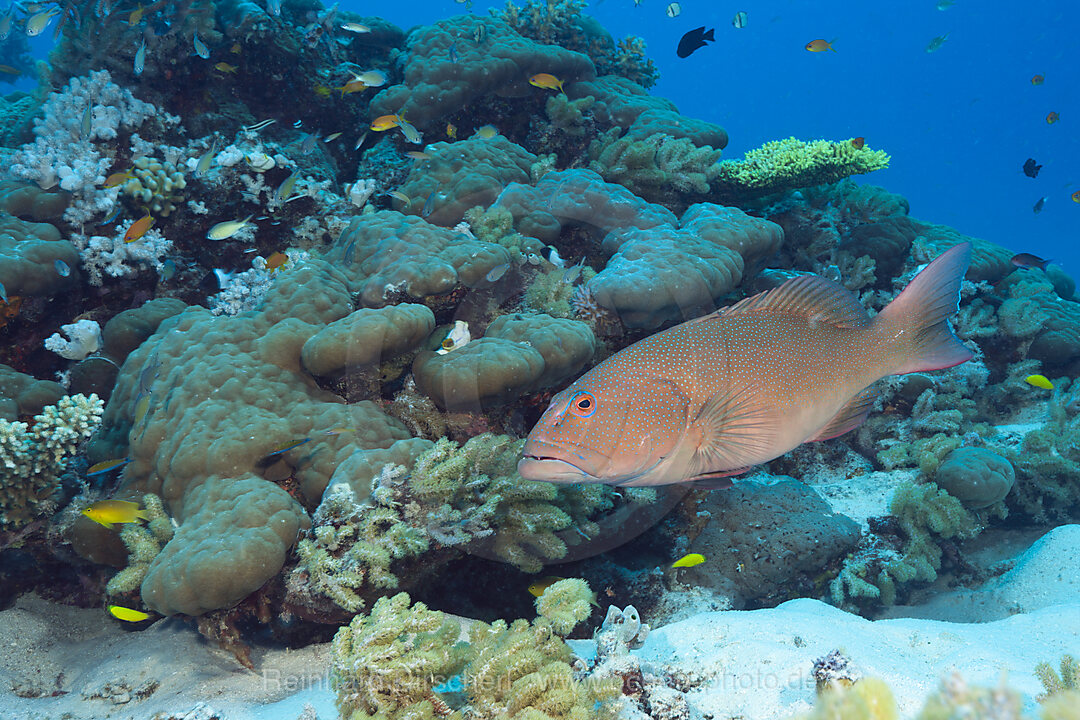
[{"xmin": 713, "ymin": 137, "xmax": 890, "ymax": 199}]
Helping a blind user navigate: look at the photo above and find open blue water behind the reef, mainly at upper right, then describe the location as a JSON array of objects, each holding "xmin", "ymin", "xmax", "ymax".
[{"xmin": 365, "ymin": 0, "xmax": 1080, "ymax": 276}]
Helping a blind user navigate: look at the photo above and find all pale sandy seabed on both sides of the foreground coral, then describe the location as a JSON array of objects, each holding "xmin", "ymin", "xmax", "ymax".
[{"xmin": 0, "ymin": 525, "xmax": 1080, "ymax": 720}]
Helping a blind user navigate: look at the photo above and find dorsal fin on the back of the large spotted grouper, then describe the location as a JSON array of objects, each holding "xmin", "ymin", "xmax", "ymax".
[{"xmin": 713, "ymin": 275, "xmax": 870, "ymax": 327}]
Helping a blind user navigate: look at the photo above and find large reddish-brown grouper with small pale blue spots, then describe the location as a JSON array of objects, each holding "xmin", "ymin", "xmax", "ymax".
[{"xmin": 517, "ymin": 243, "xmax": 972, "ymax": 486}]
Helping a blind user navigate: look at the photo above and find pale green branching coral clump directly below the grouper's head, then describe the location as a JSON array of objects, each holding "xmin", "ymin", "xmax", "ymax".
[{"xmin": 288, "ymin": 434, "xmax": 653, "ymax": 614}]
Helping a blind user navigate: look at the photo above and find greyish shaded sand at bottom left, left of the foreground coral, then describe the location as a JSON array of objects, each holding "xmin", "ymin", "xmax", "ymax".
[{"xmin": 0, "ymin": 595, "xmax": 337, "ymax": 720}]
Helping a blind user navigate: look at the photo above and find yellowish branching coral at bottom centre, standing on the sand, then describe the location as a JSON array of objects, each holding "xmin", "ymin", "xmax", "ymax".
[{"xmin": 330, "ymin": 581, "xmax": 622, "ymax": 720}]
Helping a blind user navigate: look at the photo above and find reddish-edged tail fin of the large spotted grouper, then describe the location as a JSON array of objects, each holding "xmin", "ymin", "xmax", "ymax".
[{"xmin": 872, "ymin": 243, "xmax": 972, "ymax": 375}]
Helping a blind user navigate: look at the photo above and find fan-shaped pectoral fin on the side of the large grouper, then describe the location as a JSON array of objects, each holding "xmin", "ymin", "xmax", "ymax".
[{"xmin": 687, "ymin": 386, "xmax": 775, "ymax": 479}]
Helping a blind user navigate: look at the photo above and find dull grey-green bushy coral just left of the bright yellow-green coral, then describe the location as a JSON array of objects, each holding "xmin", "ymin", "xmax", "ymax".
[{"xmin": 589, "ymin": 127, "xmax": 720, "ymax": 204}]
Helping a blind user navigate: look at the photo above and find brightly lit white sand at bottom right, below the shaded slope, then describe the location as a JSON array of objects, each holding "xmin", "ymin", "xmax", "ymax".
[{"xmin": 591, "ymin": 599, "xmax": 1080, "ymax": 720}]
